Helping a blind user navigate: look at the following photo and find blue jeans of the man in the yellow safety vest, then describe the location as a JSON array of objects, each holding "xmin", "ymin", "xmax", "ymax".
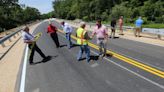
[{"xmin": 77, "ymin": 45, "xmax": 90, "ymax": 62}]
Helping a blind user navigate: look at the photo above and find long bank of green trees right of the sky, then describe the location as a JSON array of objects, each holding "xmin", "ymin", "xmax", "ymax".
[{"xmin": 53, "ymin": 0, "xmax": 164, "ymax": 24}]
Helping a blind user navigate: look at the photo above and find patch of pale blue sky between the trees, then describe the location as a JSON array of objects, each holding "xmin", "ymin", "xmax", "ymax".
[{"xmin": 19, "ymin": 0, "xmax": 54, "ymax": 14}]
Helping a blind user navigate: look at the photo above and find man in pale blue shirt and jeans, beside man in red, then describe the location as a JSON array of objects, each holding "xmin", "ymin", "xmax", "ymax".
[{"xmin": 61, "ymin": 22, "xmax": 73, "ymax": 49}]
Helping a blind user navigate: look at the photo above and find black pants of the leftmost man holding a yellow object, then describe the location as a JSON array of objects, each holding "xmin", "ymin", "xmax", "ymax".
[{"xmin": 28, "ymin": 44, "xmax": 46, "ymax": 63}]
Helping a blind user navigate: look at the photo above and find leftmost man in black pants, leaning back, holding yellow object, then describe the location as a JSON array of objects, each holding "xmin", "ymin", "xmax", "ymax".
[{"xmin": 22, "ymin": 27, "xmax": 50, "ymax": 64}]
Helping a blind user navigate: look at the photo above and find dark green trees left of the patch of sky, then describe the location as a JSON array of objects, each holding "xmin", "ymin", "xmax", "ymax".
[{"xmin": 0, "ymin": 0, "xmax": 40, "ymax": 31}]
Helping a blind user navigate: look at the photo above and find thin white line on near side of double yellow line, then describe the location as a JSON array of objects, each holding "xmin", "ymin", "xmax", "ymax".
[{"xmin": 91, "ymin": 50, "xmax": 164, "ymax": 89}]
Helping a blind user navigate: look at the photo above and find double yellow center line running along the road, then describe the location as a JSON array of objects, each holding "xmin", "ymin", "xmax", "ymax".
[{"xmin": 59, "ymin": 30, "xmax": 164, "ymax": 78}]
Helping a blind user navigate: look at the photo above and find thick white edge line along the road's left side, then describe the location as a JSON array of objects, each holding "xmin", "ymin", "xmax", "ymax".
[{"xmin": 19, "ymin": 45, "xmax": 28, "ymax": 92}]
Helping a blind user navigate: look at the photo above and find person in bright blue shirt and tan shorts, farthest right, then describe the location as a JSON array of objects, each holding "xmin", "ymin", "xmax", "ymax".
[{"xmin": 134, "ymin": 17, "xmax": 143, "ymax": 37}]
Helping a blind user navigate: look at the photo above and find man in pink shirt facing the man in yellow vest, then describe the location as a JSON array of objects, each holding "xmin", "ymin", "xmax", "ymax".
[{"xmin": 92, "ymin": 20, "xmax": 108, "ymax": 57}]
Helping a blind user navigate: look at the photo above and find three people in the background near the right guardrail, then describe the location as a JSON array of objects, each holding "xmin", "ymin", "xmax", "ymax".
[{"xmin": 110, "ymin": 16, "xmax": 143, "ymax": 38}]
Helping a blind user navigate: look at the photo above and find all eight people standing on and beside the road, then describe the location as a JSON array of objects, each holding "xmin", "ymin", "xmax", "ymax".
[{"xmin": 22, "ymin": 16, "xmax": 143, "ymax": 64}]
